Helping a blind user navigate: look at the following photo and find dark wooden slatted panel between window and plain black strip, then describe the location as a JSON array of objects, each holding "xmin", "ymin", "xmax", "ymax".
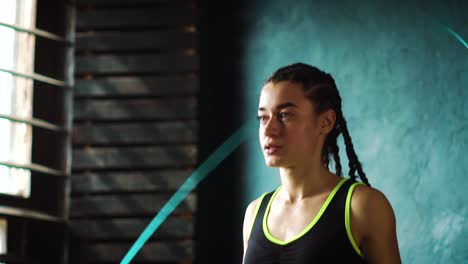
[{"xmin": 70, "ymin": 0, "xmax": 199, "ymax": 264}]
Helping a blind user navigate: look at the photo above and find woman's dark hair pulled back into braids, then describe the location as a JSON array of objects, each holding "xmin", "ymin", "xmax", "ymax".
[{"xmin": 265, "ymin": 63, "xmax": 370, "ymax": 186}]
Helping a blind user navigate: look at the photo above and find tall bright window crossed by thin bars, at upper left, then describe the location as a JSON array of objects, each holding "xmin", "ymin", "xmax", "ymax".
[{"xmin": 0, "ymin": 0, "xmax": 36, "ymax": 198}]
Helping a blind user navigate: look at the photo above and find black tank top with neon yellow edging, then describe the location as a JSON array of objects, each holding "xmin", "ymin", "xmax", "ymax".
[{"xmin": 244, "ymin": 178, "xmax": 366, "ymax": 264}]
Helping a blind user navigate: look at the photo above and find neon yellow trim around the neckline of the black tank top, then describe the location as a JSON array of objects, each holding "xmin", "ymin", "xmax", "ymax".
[{"xmin": 263, "ymin": 178, "xmax": 347, "ymax": 245}]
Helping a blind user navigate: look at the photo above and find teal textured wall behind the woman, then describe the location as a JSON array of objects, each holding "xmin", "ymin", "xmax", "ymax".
[{"xmin": 243, "ymin": 0, "xmax": 468, "ymax": 263}]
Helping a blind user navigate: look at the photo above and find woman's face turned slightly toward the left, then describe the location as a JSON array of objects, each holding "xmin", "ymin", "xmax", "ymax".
[{"xmin": 258, "ymin": 81, "xmax": 324, "ymax": 168}]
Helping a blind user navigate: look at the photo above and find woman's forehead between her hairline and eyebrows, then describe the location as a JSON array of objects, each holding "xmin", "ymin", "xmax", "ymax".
[{"xmin": 258, "ymin": 81, "xmax": 310, "ymax": 110}]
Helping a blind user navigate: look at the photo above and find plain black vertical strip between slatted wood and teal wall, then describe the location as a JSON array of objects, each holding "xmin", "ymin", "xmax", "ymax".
[{"xmin": 195, "ymin": 1, "xmax": 250, "ymax": 264}]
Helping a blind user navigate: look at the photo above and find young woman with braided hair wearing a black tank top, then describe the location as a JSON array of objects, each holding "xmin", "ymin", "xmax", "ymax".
[{"xmin": 243, "ymin": 63, "xmax": 401, "ymax": 264}]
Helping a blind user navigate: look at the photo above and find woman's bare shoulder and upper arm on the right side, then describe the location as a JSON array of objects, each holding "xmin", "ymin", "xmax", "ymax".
[{"xmin": 351, "ymin": 185, "xmax": 401, "ymax": 264}]
